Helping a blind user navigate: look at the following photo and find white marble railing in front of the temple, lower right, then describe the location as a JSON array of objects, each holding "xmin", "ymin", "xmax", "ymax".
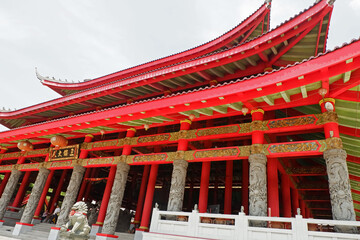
[{"xmin": 143, "ymin": 208, "xmax": 360, "ymax": 240}]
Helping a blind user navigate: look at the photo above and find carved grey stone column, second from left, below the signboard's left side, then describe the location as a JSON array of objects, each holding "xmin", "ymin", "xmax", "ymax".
[{"xmin": 20, "ymin": 167, "xmax": 50, "ymax": 223}]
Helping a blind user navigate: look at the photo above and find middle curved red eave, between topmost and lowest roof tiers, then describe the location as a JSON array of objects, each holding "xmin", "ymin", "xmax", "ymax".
[{"xmin": 0, "ymin": 1, "xmax": 332, "ymax": 128}]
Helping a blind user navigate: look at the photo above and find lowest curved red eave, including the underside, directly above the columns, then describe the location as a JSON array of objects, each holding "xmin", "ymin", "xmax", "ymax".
[{"xmin": 0, "ymin": 35, "xmax": 360, "ymax": 143}]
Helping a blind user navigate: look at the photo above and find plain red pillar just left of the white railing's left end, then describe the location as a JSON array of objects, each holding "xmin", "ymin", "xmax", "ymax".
[{"xmin": 139, "ymin": 164, "xmax": 159, "ymax": 231}]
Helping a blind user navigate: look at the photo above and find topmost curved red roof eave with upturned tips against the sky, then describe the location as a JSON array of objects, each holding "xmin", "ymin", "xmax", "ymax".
[{"xmin": 41, "ymin": 3, "xmax": 271, "ymax": 96}]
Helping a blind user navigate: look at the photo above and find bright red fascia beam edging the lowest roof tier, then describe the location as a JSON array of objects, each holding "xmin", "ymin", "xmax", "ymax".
[{"xmin": 0, "ymin": 35, "xmax": 360, "ymax": 142}]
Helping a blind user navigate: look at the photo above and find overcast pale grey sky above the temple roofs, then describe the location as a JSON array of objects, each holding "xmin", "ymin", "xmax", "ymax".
[{"xmin": 0, "ymin": 0, "xmax": 360, "ymax": 131}]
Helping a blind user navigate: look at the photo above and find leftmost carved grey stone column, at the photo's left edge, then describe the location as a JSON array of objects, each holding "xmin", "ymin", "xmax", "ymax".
[{"xmin": 0, "ymin": 169, "xmax": 22, "ymax": 219}]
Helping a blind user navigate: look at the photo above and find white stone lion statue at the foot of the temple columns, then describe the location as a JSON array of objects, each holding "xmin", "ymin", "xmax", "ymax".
[{"xmin": 59, "ymin": 202, "xmax": 90, "ymax": 240}]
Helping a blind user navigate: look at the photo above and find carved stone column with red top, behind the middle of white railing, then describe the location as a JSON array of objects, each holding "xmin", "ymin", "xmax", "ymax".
[{"xmin": 249, "ymin": 109, "xmax": 267, "ymax": 218}]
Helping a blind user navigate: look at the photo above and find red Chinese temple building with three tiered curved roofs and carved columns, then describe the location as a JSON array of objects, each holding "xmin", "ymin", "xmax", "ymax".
[{"xmin": 0, "ymin": 0, "xmax": 360, "ymax": 240}]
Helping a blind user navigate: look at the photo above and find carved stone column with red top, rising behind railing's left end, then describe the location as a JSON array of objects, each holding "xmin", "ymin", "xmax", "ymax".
[{"xmin": 167, "ymin": 119, "xmax": 191, "ymax": 211}]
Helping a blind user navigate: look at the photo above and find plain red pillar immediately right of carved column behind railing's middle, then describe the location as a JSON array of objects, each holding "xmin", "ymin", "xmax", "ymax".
[{"xmin": 267, "ymin": 158, "xmax": 280, "ymax": 217}]
